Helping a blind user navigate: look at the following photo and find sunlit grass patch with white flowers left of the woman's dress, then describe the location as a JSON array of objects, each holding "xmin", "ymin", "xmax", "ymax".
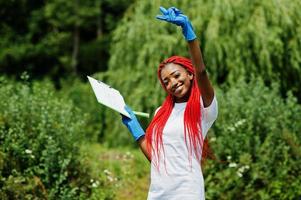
[{"xmin": 81, "ymin": 144, "xmax": 150, "ymax": 200}]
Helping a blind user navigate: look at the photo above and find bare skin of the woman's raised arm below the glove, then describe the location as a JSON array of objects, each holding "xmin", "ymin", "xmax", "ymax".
[{"xmin": 188, "ymin": 39, "xmax": 214, "ymax": 107}]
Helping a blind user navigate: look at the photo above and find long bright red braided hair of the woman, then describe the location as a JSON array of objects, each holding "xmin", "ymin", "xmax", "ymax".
[{"xmin": 145, "ymin": 56, "xmax": 207, "ymax": 166}]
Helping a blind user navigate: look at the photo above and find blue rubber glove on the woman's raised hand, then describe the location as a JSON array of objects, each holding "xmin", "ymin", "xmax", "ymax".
[{"xmin": 156, "ymin": 6, "xmax": 196, "ymax": 41}]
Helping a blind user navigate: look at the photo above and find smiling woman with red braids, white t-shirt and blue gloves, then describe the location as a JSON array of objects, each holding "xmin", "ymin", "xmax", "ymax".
[{"xmin": 123, "ymin": 7, "xmax": 217, "ymax": 200}]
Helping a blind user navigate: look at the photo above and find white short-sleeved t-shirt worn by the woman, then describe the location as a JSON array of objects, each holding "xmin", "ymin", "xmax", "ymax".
[{"xmin": 147, "ymin": 97, "xmax": 218, "ymax": 200}]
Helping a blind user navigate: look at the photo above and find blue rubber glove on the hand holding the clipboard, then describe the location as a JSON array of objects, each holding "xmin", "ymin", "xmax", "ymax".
[{"xmin": 122, "ymin": 106, "xmax": 145, "ymax": 141}]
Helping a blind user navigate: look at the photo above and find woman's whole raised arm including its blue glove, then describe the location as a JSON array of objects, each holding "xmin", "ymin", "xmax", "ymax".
[{"xmin": 157, "ymin": 7, "xmax": 214, "ymax": 107}]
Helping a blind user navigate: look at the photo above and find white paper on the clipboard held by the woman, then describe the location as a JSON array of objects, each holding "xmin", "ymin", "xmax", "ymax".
[{"xmin": 87, "ymin": 76, "xmax": 131, "ymax": 118}]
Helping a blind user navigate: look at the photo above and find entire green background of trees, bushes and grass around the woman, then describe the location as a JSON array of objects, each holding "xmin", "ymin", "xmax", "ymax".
[{"xmin": 0, "ymin": 0, "xmax": 301, "ymax": 199}]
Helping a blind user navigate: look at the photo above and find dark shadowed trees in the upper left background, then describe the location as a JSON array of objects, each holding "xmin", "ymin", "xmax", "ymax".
[{"xmin": 0, "ymin": 0, "xmax": 133, "ymax": 79}]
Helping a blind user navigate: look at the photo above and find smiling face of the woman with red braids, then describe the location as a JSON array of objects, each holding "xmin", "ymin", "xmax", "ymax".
[{"xmin": 161, "ymin": 63, "xmax": 193, "ymax": 103}]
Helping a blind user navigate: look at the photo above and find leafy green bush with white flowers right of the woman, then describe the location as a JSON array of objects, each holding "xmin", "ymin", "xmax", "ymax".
[{"xmin": 205, "ymin": 79, "xmax": 301, "ymax": 199}]
